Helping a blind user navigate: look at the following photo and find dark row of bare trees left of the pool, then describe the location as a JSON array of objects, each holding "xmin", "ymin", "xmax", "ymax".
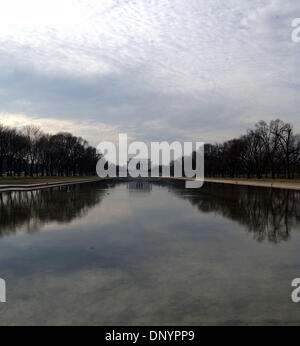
[{"xmin": 0, "ymin": 124, "xmax": 99, "ymax": 176}]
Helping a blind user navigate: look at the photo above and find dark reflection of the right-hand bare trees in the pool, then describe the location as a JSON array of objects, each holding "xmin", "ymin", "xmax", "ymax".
[{"xmin": 166, "ymin": 183, "xmax": 300, "ymax": 243}]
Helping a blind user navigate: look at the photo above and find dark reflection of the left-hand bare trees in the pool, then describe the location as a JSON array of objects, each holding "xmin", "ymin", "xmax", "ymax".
[{"xmin": 0, "ymin": 183, "xmax": 107, "ymax": 236}]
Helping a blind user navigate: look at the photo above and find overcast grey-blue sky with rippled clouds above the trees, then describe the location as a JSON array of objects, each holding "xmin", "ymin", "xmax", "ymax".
[{"xmin": 0, "ymin": 0, "xmax": 300, "ymax": 145}]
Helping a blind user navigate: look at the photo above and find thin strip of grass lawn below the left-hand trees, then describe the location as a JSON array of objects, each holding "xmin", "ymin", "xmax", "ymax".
[{"xmin": 0, "ymin": 176, "xmax": 98, "ymax": 185}]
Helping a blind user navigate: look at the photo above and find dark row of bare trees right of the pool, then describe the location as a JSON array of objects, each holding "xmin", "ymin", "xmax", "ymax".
[{"xmin": 204, "ymin": 119, "xmax": 300, "ymax": 179}]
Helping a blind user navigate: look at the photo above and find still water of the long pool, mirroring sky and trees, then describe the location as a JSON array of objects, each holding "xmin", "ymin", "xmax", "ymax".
[{"xmin": 0, "ymin": 181, "xmax": 300, "ymax": 325}]
